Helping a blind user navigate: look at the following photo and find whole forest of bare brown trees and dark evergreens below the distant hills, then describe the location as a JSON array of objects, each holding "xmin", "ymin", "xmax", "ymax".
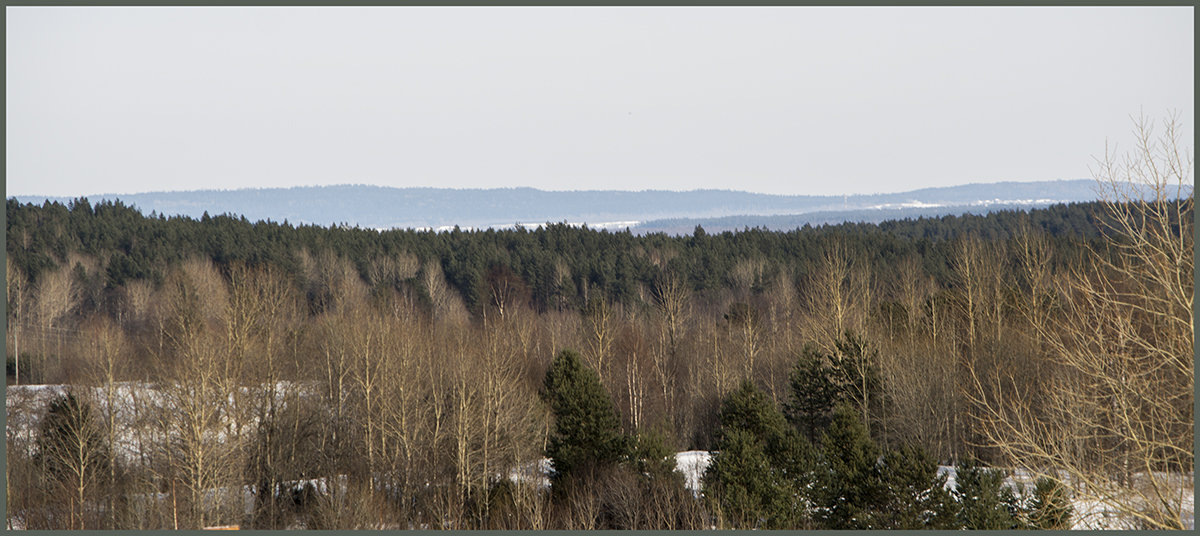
[{"xmin": 6, "ymin": 178, "xmax": 1193, "ymax": 529}]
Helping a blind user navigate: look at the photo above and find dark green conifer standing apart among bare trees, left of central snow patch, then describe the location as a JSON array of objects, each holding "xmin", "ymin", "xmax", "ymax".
[{"xmin": 541, "ymin": 350, "xmax": 628, "ymax": 486}]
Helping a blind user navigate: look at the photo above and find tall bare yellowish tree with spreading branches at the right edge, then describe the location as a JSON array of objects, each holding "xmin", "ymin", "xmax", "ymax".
[{"xmin": 972, "ymin": 115, "xmax": 1195, "ymax": 529}]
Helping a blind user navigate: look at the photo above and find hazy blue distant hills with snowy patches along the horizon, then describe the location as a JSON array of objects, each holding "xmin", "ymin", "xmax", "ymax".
[{"xmin": 17, "ymin": 179, "xmax": 1097, "ymax": 231}]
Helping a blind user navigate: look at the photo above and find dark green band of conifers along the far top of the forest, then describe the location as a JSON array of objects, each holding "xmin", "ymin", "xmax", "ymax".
[{"xmin": 6, "ymin": 199, "xmax": 1118, "ymax": 313}]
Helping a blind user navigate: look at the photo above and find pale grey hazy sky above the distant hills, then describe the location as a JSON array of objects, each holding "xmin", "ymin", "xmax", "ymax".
[{"xmin": 5, "ymin": 7, "xmax": 1194, "ymax": 195}]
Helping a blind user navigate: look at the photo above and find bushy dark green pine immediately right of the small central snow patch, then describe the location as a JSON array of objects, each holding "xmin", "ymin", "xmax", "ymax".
[{"xmin": 704, "ymin": 381, "xmax": 814, "ymax": 529}]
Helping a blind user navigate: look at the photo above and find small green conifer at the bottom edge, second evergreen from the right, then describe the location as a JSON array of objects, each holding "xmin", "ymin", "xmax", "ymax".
[{"xmin": 954, "ymin": 459, "xmax": 1021, "ymax": 530}]
